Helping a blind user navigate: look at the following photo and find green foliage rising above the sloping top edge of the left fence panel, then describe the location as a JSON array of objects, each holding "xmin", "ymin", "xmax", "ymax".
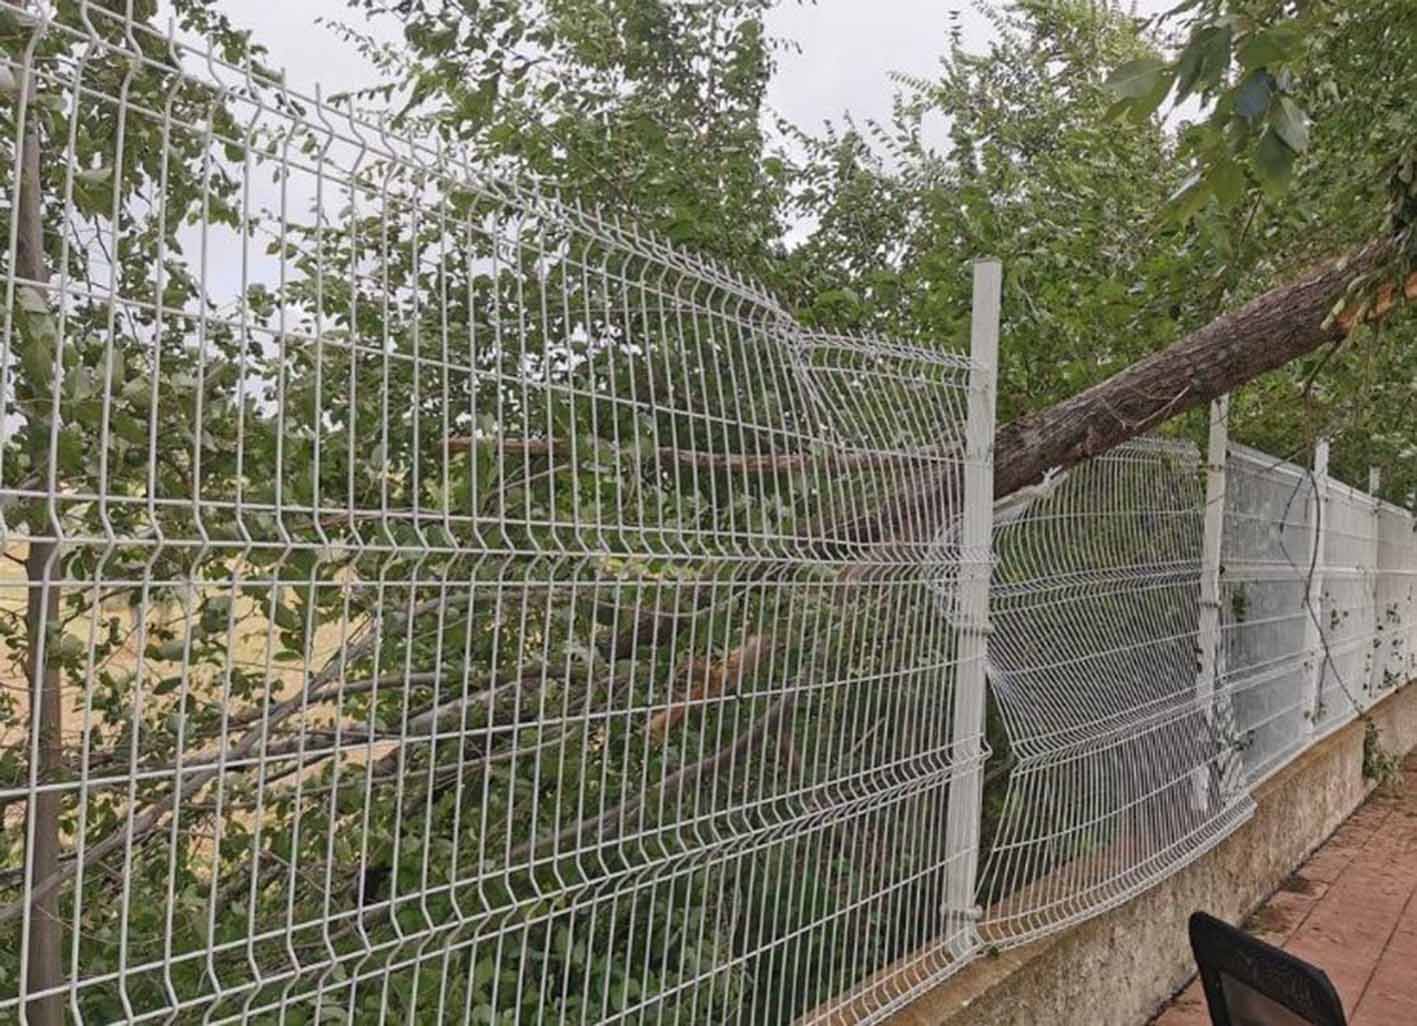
[{"xmin": 338, "ymin": 0, "xmax": 788, "ymax": 279}]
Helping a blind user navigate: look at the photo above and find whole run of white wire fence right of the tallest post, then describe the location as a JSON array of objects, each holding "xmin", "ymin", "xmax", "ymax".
[{"xmin": 979, "ymin": 400, "xmax": 1417, "ymax": 945}]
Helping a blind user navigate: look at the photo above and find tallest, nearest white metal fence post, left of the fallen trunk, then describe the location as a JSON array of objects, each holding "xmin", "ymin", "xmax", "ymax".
[{"xmin": 945, "ymin": 259, "xmax": 1002, "ymax": 958}]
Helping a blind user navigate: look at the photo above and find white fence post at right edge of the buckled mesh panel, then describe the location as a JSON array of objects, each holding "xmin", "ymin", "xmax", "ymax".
[{"xmin": 1193, "ymin": 395, "xmax": 1230, "ymax": 809}]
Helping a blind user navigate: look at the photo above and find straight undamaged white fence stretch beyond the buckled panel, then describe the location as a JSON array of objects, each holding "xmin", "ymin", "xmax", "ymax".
[{"xmin": 1221, "ymin": 445, "xmax": 1417, "ymax": 781}]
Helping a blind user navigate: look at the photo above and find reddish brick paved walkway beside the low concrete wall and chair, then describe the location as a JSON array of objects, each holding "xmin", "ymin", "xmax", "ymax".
[{"xmin": 1153, "ymin": 755, "xmax": 1417, "ymax": 1026}]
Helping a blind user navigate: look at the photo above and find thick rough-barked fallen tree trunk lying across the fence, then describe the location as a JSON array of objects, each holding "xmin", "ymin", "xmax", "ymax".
[{"xmin": 829, "ymin": 239, "xmax": 1417, "ymax": 544}]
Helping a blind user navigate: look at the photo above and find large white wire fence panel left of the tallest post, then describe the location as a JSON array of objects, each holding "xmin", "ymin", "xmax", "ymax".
[{"xmin": 0, "ymin": 3, "xmax": 992, "ymax": 1026}]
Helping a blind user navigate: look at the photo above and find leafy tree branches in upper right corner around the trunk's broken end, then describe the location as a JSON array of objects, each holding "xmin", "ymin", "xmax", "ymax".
[{"xmin": 1110, "ymin": 0, "xmax": 1417, "ymax": 503}]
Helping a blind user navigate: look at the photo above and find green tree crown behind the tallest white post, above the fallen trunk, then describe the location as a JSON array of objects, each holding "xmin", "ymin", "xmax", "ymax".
[{"xmin": 791, "ymin": 0, "xmax": 1223, "ymax": 419}]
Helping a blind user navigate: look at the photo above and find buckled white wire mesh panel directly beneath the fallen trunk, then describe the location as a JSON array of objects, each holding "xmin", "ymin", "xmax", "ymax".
[{"xmin": 981, "ymin": 439, "xmax": 1251, "ymax": 944}]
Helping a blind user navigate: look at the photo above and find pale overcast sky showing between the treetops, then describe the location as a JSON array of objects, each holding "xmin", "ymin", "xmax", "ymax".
[{"xmin": 182, "ymin": 0, "xmax": 1176, "ymax": 144}]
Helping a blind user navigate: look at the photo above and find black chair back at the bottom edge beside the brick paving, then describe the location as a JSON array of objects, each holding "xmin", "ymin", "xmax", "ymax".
[{"xmin": 1190, "ymin": 913, "xmax": 1348, "ymax": 1026}]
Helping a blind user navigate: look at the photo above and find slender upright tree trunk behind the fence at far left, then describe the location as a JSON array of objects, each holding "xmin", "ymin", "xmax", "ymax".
[{"xmin": 14, "ymin": 54, "xmax": 64, "ymax": 1026}]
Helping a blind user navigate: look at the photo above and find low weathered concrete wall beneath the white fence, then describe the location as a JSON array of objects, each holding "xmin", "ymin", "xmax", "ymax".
[{"xmin": 887, "ymin": 684, "xmax": 1417, "ymax": 1026}]
